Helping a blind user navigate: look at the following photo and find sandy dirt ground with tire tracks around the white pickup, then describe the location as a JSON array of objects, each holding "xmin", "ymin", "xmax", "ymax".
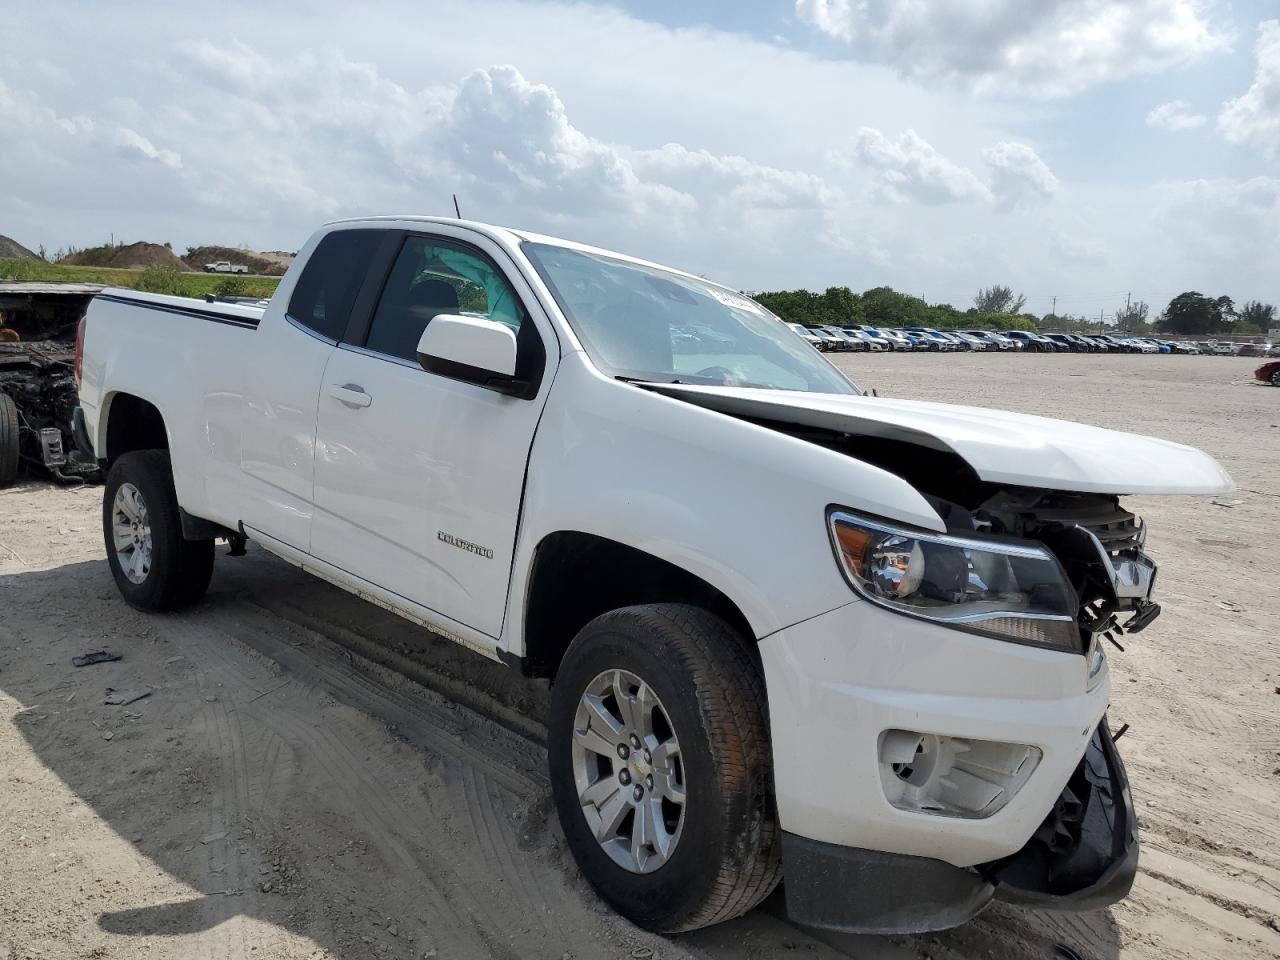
[{"xmin": 0, "ymin": 355, "xmax": 1280, "ymax": 960}]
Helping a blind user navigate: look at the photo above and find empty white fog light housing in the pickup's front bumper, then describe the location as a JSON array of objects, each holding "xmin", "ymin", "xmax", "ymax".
[{"xmin": 879, "ymin": 730, "xmax": 1041, "ymax": 819}]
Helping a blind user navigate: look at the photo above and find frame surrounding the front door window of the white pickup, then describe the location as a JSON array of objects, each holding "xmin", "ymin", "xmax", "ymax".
[{"xmin": 338, "ymin": 229, "xmax": 547, "ymax": 399}]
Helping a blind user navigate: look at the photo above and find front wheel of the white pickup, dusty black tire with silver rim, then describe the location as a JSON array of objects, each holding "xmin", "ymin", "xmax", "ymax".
[{"xmin": 548, "ymin": 604, "xmax": 781, "ymax": 933}]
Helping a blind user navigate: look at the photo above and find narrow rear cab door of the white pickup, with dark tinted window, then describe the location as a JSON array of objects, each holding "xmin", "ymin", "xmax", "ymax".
[{"xmin": 241, "ymin": 230, "xmax": 385, "ymax": 550}]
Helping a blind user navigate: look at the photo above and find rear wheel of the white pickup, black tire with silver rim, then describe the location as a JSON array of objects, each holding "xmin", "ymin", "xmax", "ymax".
[{"xmin": 102, "ymin": 451, "xmax": 214, "ymax": 613}]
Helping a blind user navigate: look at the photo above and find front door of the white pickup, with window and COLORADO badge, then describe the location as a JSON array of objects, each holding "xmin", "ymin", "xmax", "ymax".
[{"xmin": 311, "ymin": 228, "xmax": 556, "ymax": 639}]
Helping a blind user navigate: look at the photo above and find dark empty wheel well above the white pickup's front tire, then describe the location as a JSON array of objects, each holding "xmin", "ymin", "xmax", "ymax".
[{"xmin": 521, "ymin": 531, "xmax": 755, "ymax": 678}]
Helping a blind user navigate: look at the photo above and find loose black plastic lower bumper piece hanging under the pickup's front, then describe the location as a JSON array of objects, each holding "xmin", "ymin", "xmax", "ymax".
[{"xmin": 782, "ymin": 719, "xmax": 1138, "ymax": 933}]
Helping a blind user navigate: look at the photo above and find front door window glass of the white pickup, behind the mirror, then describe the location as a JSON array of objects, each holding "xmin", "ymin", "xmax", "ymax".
[{"xmin": 365, "ymin": 237, "xmax": 525, "ymax": 361}]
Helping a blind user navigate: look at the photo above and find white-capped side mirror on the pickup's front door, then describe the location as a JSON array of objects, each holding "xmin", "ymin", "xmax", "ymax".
[{"xmin": 417, "ymin": 314, "xmax": 527, "ymax": 394}]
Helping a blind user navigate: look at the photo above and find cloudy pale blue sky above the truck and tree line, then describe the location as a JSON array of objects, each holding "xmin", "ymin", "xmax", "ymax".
[{"xmin": 0, "ymin": 0, "xmax": 1280, "ymax": 317}]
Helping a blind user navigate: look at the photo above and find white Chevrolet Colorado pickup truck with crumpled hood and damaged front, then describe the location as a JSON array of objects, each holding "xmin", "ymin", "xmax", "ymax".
[{"xmin": 76, "ymin": 218, "xmax": 1231, "ymax": 932}]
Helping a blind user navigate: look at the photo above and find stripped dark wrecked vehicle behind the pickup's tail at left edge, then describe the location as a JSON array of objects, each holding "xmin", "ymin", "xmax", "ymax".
[{"xmin": 0, "ymin": 282, "xmax": 101, "ymax": 488}]
